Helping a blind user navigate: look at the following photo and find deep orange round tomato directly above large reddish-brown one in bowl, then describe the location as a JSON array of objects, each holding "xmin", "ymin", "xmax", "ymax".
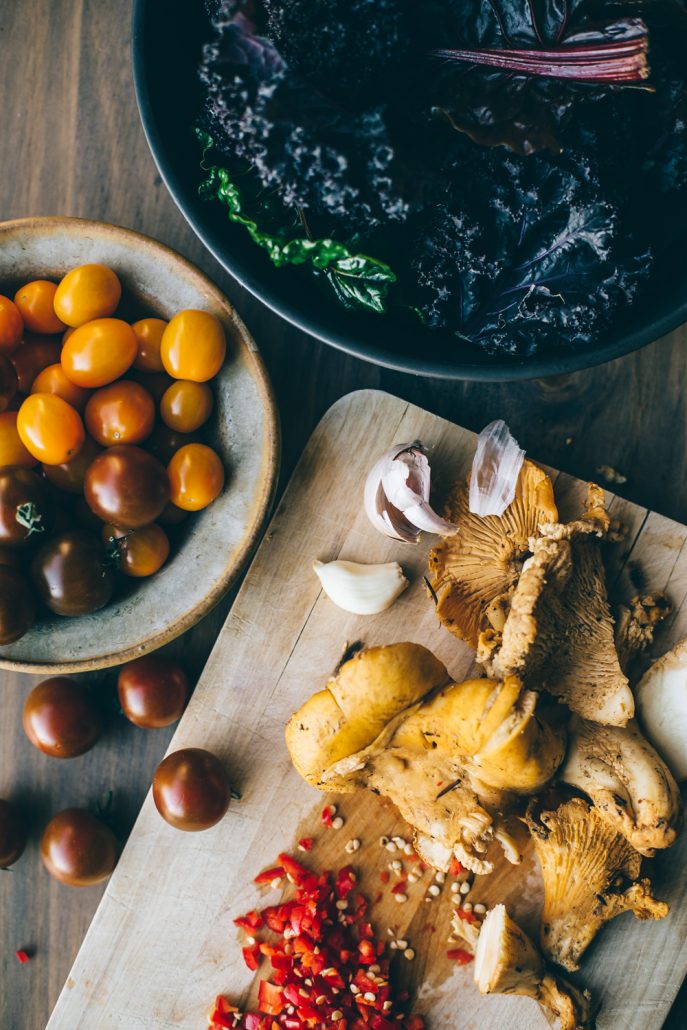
[{"xmin": 85, "ymin": 379, "xmax": 156, "ymax": 447}]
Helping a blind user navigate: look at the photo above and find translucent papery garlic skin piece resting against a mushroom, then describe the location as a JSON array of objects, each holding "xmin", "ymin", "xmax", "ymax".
[{"xmin": 470, "ymin": 418, "xmax": 525, "ymax": 516}]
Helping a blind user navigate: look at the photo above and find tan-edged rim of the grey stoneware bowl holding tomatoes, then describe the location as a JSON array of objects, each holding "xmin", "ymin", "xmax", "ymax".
[{"xmin": 0, "ymin": 215, "xmax": 281, "ymax": 675}]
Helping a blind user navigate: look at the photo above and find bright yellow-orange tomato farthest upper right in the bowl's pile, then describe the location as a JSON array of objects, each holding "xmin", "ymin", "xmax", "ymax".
[{"xmin": 160, "ymin": 309, "xmax": 227, "ymax": 383}]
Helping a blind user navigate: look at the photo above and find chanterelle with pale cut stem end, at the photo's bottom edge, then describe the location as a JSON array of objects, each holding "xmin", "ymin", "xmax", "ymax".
[{"xmin": 475, "ymin": 904, "xmax": 594, "ymax": 1030}]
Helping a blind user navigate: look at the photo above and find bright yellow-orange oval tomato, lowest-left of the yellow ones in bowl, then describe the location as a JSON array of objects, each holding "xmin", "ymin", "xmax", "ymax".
[{"xmin": 16, "ymin": 393, "xmax": 85, "ymax": 465}]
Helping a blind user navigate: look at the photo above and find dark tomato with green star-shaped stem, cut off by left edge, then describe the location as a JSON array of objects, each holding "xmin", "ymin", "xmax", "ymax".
[{"xmin": 0, "ymin": 468, "xmax": 55, "ymax": 550}]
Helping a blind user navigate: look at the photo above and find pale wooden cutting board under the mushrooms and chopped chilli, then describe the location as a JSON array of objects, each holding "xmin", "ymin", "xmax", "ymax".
[{"xmin": 48, "ymin": 390, "xmax": 687, "ymax": 1030}]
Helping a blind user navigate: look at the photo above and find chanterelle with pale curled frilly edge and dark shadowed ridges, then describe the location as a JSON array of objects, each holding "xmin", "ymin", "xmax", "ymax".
[{"xmin": 477, "ymin": 484, "xmax": 634, "ymax": 726}]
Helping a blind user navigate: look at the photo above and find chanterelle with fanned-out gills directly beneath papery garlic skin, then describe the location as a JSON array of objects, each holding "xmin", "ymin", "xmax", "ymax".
[{"xmin": 430, "ymin": 461, "xmax": 558, "ymax": 648}]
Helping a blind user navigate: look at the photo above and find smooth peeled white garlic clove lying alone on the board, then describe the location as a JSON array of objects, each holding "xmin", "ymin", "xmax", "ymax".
[{"xmin": 312, "ymin": 560, "xmax": 408, "ymax": 615}]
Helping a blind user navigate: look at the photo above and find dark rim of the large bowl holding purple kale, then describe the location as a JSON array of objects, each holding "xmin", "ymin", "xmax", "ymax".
[{"xmin": 131, "ymin": 0, "xmax": 687, "ymax": 382}]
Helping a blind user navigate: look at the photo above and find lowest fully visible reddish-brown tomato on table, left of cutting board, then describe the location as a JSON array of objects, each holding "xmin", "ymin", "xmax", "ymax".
[{"xmin": 40, "ymin": 809, "xmax": 119, "ymax": 887}]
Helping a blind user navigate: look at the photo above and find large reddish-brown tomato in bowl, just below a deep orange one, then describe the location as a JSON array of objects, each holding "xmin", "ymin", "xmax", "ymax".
[{"xmin": 83, "ymin": 444, "xmax": 169, "ymax": 529}]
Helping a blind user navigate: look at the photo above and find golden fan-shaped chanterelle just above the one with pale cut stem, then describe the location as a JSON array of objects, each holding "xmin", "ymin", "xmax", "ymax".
[{"xmin": 527, "ymin": 797, "xmax": 668, "ymax": 969}]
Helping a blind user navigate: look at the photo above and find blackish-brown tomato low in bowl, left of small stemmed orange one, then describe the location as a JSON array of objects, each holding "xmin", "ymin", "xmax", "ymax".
[{"xmin": 31, "ymin": 531, "xmax": 115, "ymax": 615}]
